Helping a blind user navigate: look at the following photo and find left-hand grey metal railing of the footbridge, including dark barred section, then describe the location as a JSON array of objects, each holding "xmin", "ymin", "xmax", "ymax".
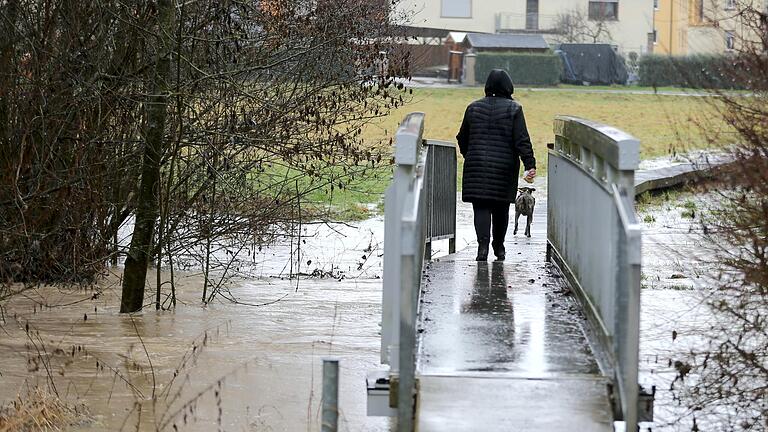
[{"xmin": 381, "ymin": 113, "xmax": 456, "ymax": 432}]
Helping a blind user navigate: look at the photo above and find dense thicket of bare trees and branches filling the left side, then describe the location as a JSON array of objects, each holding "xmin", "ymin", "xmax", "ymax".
[{"xmin": 0, "ymin": 0, "xmax": 408, "ymax": 312}]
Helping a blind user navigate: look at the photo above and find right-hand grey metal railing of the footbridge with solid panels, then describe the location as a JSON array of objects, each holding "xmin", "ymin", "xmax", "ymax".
[{"xmin": 547, "ymin": 117, "xmax": 642, "ymax": 430}]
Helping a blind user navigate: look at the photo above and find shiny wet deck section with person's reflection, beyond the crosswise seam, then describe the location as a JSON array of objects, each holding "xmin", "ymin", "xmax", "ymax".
[{"xmin": 420, "ymin": 208, "xmax": 599, "ymax": 376}]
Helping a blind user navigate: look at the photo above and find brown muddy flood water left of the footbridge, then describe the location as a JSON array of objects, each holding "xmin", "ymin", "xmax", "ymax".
[{"xmin": 0, "ymin": 274, "xmax": 389, "ymax": 431}]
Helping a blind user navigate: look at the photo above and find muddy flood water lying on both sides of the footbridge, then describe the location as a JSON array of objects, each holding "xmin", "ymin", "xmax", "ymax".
[{"xmin": 0, "ymin": 179, "xmax": 716, "ymax": 431}]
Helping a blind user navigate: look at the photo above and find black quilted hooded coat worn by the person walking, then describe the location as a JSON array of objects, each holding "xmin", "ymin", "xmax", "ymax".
[{"xmin": 456, "ymin": 69, "xmax": 536, "ymax": 203}]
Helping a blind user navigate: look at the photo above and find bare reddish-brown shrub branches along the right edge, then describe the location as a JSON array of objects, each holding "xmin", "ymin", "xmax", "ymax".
[{"xmin": 675, "ymin": 0, "xmax": 768, "ymax": 431}]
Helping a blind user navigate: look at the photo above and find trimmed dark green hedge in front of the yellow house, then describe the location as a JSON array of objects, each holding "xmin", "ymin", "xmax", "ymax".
[{"xmin": 639, "ymin": 55, "xmax": 746, "ymax": 89}]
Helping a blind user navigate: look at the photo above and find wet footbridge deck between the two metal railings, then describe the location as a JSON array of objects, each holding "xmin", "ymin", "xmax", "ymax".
[{"xmin": 417, "ymin": 199, "xmax": 613, "ymax": 432}]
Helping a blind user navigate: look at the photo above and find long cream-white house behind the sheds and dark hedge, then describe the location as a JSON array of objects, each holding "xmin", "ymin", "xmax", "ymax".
[{"xmin": 396, "ymin": 0, "xmax": 654, "ymax": 54}]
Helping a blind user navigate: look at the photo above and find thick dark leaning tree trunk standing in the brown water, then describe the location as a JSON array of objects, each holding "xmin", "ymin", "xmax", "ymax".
[{"xmin": 120, "ymin": 0, "xmax": 175, "ymax": 312}]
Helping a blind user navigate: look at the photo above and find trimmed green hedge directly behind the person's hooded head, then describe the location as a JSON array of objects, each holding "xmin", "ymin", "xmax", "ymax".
[{"xmin": 475, "ymin": 53, "xmax": 562, "ymax": 85}]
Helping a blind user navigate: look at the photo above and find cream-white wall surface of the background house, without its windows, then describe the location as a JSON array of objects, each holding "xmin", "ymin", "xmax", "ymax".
[{"xmin": 398, "ymin": 0, "xmax": 653, "ymax": 53}]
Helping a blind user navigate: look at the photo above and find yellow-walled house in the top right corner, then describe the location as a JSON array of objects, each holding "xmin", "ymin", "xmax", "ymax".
[{"xmin": 653, "ymin": 0, "xmax": 768, "ymax": 55}]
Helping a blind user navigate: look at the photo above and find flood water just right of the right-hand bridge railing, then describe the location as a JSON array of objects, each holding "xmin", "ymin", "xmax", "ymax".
[{"xmin": 640, "ymin": 193, "xmax": 717, "ymax": 432}]
